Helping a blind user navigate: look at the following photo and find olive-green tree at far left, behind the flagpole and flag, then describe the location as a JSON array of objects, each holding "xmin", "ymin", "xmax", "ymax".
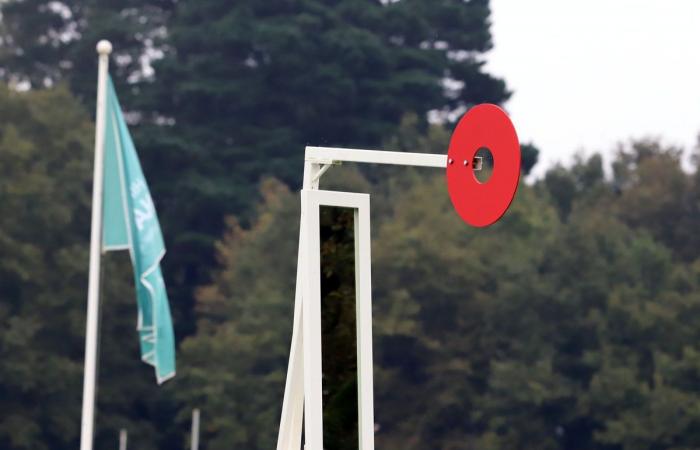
[{"xmin": 0, "ymin": 86, "xmax": 184, "ymax": 450}]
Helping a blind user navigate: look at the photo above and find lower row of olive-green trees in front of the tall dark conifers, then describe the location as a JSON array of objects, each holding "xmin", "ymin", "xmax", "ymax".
[{"xmin": 5, "ymin": 84, "xmax": 700, "ymax": 450}]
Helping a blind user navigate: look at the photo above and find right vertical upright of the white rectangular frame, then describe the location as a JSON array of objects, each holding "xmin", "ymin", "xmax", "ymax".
[{"xmin": 355, "ymin": 197, "xmax": 374, "ymax": 450}]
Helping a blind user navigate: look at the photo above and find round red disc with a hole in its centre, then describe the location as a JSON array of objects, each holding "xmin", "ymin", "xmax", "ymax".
[{"xmin": 447, "ymin": 104, "xmax": 520, "ymax": 227}]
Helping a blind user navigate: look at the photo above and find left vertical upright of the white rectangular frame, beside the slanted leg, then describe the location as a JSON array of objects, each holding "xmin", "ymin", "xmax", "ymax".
[{"xmin": 301, "ymin": 189, "xmax": 323, "ymax": 450}]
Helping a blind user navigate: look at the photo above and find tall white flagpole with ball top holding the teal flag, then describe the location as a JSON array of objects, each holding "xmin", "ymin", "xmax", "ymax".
[{"xmin": 80, "ymin": 40, "xmax": 112, "ymax": 450}]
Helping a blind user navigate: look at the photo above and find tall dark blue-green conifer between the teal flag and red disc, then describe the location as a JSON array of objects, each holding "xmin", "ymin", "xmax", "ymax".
[{"xmin": 135, "ymin": 0, "xmax": 508, "ymax": 342}]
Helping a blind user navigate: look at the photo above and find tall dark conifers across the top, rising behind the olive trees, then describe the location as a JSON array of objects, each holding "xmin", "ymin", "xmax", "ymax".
[{"xmin": 0, "ymin": 0, "xmax": 509, "ymax": 342}]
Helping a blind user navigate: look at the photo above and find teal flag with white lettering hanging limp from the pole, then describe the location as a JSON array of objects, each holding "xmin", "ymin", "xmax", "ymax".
[{"xmin": 102, "ymin": 78, "xmax": 175, "ymax": 384}]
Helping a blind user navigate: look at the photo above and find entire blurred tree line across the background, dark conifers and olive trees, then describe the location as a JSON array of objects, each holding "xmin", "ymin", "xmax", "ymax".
[{"xmin": 0, "ymin": 0, "xmax": 700, "ymax": 450}]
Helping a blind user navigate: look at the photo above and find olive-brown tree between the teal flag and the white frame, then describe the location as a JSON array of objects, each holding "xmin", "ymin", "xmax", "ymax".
[{"xmin": 175, "ymin": 180, "xmax": 299, "ymax": 450}]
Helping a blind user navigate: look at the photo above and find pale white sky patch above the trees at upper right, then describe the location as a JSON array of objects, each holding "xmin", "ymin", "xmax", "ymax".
[{"xmin": 487, "ymin": 0, "xmax": 700, "ymax": 178}]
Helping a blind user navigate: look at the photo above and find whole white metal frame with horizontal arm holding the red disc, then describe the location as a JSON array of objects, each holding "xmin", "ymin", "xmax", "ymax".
[{"xmin": 277, "ymin": 147, "xmax": 447, "ymax": 450}]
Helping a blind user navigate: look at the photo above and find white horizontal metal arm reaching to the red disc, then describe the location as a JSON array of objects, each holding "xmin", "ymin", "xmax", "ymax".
[{"xmin": 305, "ymin": 147, "xmax": 447, "ymax": 169}]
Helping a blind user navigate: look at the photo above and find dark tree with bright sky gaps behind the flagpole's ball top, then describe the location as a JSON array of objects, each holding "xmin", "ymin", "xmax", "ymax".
[{"xmin": 0, "ymin": 0, "xmax": 176, "ymax": 97}]
